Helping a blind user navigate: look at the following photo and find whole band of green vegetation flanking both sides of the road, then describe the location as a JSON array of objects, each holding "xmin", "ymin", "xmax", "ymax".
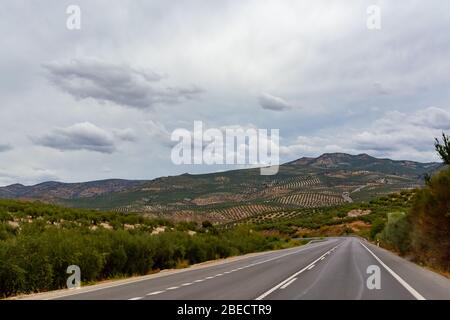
[{"xmin": 0, "ymin": 135, "xmax": 450, "ymax": 298}]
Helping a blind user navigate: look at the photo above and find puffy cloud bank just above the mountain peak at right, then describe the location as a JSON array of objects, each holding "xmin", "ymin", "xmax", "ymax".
[{"xmin": 281, "ymin": 107, "xmax": 450, "ymax": 162}]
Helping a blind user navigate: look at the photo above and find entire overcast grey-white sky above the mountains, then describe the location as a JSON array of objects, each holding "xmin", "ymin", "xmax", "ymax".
[{"xmin": 0, "ymin": 0, "xmax": 450, "ymax": 185}]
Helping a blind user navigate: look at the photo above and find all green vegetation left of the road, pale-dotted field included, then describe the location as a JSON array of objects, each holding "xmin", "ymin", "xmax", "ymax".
[{"xmin": 0, "ymin": 200, "xmax": 301, "ymax": 297}]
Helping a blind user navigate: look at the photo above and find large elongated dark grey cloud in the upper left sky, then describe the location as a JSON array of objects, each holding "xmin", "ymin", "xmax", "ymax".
[{"xmin": 43, "ymin": 59, "xmax": 201, "ymax": 109}]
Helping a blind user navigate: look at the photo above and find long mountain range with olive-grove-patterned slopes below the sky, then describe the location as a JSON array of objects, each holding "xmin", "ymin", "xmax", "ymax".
[{"xmin": 0, "ymin": 153, "xmax": 443, "ymax": 222}]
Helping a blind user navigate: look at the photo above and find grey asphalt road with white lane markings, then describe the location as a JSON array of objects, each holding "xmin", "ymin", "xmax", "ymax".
[{"xmin": 37, "ymin": 237, "xmax": 450, "ymax": 300}]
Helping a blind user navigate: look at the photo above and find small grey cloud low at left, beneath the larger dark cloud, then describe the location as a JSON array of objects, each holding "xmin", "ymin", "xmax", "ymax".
[{"xmin": 32, "ymin": 122, "xmax": 116, "ymax": 153}]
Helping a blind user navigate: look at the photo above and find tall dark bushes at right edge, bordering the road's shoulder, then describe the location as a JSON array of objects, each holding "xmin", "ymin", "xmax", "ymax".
[{"xmin": 377, "ymin": 134, "xmax": 450, "ymax": 274}]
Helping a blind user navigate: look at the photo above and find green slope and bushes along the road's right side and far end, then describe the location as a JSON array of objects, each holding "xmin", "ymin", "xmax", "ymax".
[{"xmin": 249, "ymin": 134, "xmax": 450, "ymax": 275}]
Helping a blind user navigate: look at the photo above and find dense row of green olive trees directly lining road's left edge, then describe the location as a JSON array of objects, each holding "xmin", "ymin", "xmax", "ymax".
[{"xmin": 0, "ymin": 221, "xmax": 289, "ymax": 297}]
